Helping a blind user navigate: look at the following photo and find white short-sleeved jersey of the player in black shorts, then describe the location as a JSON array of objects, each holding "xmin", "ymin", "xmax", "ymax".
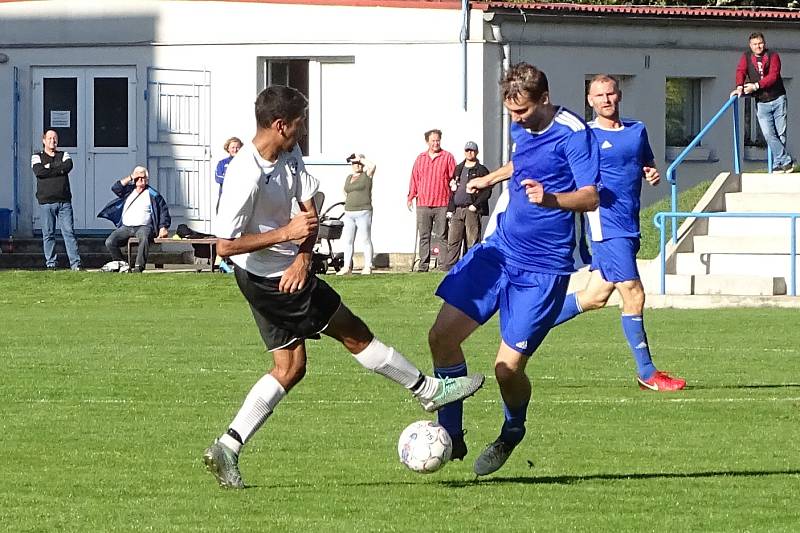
[{"xmin": 214, "ymin": 143, "xmax": 319, "ymax": 277}]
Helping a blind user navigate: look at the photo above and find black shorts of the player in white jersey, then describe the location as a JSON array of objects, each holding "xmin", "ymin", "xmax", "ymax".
[{"xmin": 234, "ymin": 266, "xmax": 342, "ymax": 352}]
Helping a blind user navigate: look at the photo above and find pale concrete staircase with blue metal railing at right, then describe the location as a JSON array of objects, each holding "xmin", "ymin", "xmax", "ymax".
[{"xmin": 642, "ymin": 173, "xmax": 800, "ymax": 296}]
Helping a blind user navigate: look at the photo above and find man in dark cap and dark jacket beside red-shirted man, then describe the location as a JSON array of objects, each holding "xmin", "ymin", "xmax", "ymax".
[{"xmin": 445, "ymin": 141, "xmax": 492, "ymax": 270}]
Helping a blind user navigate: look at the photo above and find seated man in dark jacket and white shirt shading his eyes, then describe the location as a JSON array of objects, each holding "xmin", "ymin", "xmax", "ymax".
[{"xmin": 97, "ymin": 167, "xmax": 172, "ymax": 272}]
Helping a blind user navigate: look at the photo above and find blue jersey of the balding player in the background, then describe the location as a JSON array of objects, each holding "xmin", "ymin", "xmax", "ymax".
[{"xmin": 586, "ymin": 120, "xmax": 654, "ymax": 241}]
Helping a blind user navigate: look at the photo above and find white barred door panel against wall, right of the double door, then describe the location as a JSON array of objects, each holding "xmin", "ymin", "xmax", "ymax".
[{"xmin": 147, "ymin": 68, "xmax": 209, "ymax": 232}]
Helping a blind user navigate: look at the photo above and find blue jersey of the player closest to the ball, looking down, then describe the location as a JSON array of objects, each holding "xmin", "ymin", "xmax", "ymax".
[{"xmin": 486, "ymin": 107, "xmax": 600, "ymax": 274}]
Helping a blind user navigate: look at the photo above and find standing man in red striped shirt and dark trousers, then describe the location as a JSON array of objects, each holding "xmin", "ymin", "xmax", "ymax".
[{"xmin": 406, "ymin": 130, "xmax": 456, "ymax": 272}]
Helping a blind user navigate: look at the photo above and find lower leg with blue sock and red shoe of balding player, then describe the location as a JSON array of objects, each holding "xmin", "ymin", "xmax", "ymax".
[{"xmin": 616, "ymin": 279, "xmax": 686, "ymax": 391}]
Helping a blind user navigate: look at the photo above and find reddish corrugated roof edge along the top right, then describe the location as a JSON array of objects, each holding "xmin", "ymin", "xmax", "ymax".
[{"xmin": 474, "ymin": 2, "xmax": 800, "ymax": 20}]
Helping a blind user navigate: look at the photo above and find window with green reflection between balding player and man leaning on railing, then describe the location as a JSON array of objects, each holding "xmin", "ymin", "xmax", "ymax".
[{"xmin": 665, "ymin": 78, "xmax": 700, "ymax": 146}]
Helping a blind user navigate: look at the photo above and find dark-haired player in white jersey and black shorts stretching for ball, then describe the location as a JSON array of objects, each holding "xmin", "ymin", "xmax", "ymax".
[{"xmin": 203, "ymin": 85, "xmax": 484, "ymax": 488}]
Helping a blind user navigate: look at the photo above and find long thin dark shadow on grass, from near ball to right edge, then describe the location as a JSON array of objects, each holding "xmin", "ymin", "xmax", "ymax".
[{"xmin": 441, "ymin": 470, "xmax": 800, "ymax": 487}]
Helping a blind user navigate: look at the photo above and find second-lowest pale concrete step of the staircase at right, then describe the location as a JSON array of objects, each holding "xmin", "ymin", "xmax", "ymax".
[{"xmin": 675, "ymin": 252, "xmax": 800, "ymax": 281}]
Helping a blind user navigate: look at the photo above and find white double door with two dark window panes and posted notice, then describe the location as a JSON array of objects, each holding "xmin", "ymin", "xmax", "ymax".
[{"xmin": 32, "ymin": 67, "xmax": 137, "ymax": 230}]
